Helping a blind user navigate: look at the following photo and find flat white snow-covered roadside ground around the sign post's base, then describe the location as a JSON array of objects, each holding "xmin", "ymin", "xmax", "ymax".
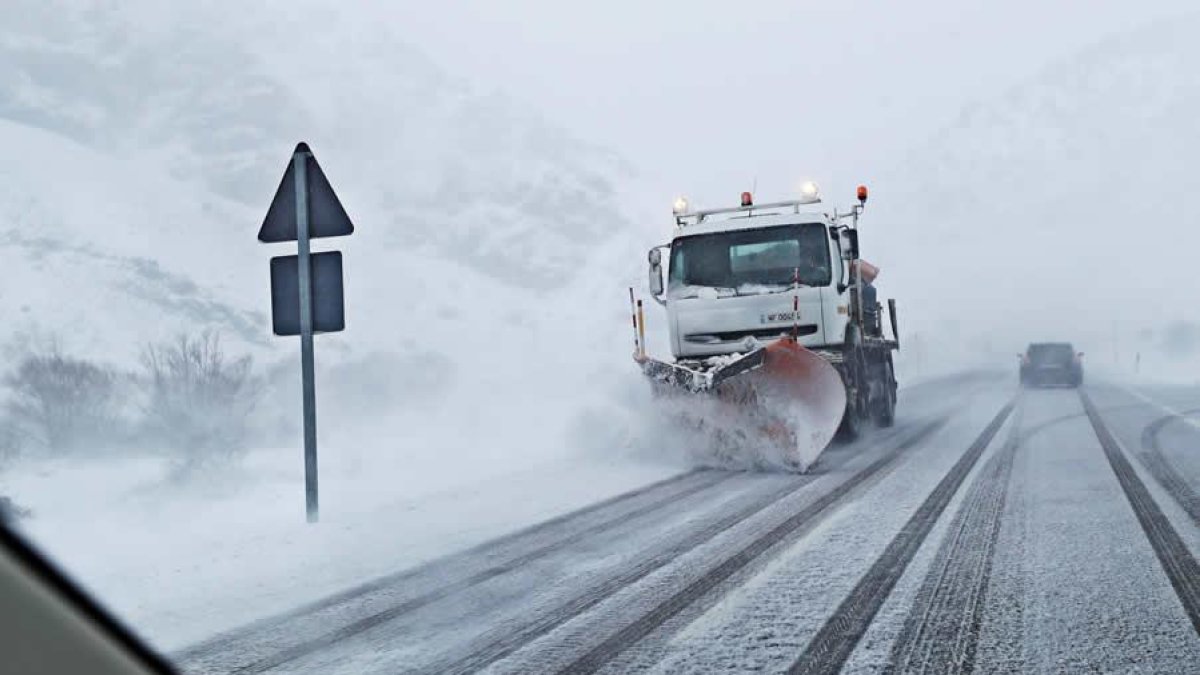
[{"xmin": 6, "ymin": 448, "xmax": 677, "ymax": 651}]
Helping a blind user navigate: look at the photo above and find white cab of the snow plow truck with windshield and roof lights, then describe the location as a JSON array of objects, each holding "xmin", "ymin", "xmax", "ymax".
[{"xmin": 650, "ymin": 195, "xmax": 857, "ymax": 359}]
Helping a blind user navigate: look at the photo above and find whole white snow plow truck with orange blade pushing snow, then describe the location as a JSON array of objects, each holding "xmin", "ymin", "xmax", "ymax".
[{"xmin": 630, "ymin": 181, "xmax": 900, "ymax": 472}]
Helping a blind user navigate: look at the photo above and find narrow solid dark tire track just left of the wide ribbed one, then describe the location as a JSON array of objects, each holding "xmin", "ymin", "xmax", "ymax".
[{"xmin": 788, "ymin": 401, "xmax": 1015, "ymax": 675}]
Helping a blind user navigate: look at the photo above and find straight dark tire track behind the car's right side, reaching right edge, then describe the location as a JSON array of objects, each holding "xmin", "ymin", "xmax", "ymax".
[{"xmin": 1079, "ymin": 390, "xmax": 1200, "ymax": 633}]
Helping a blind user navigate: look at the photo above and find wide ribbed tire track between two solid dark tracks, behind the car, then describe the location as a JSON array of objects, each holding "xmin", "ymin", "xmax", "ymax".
[{"xmin": 884, "ymin": 398, "xmax": 1027, "ymax": 674}]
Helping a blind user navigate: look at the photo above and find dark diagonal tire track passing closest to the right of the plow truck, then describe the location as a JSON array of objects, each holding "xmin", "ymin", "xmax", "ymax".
[{"xmin": 549, "ymin": 418, "xmax": 948, "ymax": 675}]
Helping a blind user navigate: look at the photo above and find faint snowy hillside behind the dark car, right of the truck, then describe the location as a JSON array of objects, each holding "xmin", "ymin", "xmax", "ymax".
[{"xmin": 866, "ymin": 14, "xmax": 1200, "ymax": 366}]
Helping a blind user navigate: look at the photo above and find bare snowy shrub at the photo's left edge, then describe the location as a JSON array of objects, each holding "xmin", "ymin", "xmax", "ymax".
[{"xmin": 0, "ymin": 345, "xmax": 120, "ymax": 455}]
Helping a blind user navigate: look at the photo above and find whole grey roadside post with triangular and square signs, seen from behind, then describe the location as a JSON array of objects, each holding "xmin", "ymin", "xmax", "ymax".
[{"xmin": 258, "ymin": 143, "xmax": 354, "ymax": 522}]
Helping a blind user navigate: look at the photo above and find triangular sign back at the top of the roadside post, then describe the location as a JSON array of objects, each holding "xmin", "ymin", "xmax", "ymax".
[{"xmin": 258, "ymin": 143, "xmax": 354, "ymax": 244}]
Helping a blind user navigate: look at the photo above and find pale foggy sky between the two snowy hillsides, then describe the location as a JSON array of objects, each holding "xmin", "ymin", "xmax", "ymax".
[{"xmin": 377, "ymin": 0, "xmax": 1194, "ymax": 203}]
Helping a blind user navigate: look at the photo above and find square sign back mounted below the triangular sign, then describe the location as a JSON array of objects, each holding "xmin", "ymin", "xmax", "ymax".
[{"xmin": 271, "ymin": 251, "xmax": 346, "ymax": 335}]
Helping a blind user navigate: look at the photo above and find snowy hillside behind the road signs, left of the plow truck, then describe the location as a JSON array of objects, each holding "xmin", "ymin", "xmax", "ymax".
[{"xmin": 0, "ymin": 2, "xmax": 657, "ymax": 393}]
